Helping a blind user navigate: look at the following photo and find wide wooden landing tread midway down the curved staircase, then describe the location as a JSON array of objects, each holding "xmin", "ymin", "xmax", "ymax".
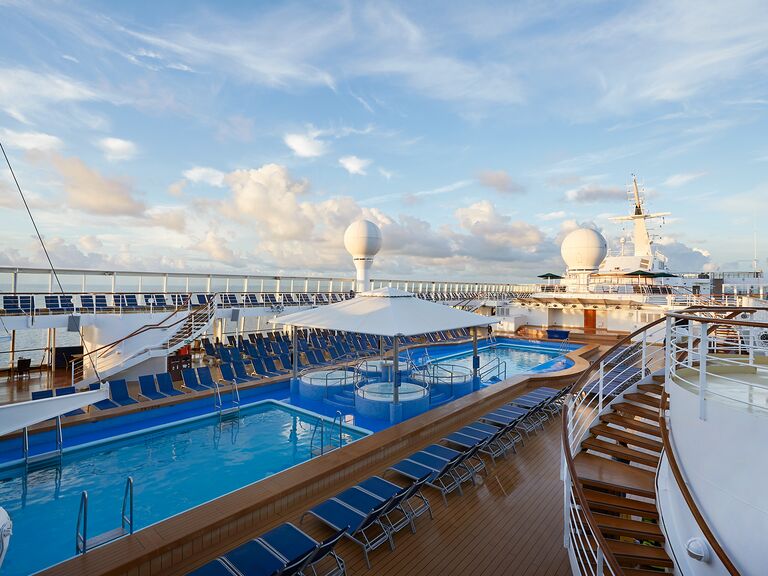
[{"xmin": 573, "ymin": 452, "xmax": 656, "ymax": 500}]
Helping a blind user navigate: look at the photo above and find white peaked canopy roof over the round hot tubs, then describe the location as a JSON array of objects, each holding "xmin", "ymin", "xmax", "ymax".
[{"xmin": 270, "ymin": 288, "xmax": 499, "ymax": 337}]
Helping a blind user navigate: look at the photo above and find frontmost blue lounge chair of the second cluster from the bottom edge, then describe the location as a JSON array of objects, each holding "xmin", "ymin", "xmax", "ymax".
[{"xmin": 301, "ymin": 490, "xmax": 394, "ymax": 568}]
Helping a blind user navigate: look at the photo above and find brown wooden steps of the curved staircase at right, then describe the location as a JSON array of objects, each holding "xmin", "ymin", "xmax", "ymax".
[{"xmin": 574, "ymin": 376, "xmax": 673, "ymax": 576}]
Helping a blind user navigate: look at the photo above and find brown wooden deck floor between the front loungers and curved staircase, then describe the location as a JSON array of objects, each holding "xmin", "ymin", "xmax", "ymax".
[{"xmin": 240, "ymin": 421, "xmax": 570, "ymax": 576}]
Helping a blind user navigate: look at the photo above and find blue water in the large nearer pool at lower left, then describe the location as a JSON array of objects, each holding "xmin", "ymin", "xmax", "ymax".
[{"xmin": 0, "ymin": 401, "xmax": 364, "ymax": 576}]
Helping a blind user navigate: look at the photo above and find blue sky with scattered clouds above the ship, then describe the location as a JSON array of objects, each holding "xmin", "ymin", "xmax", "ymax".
[{"xmin": 0, "ymin": 0, "xmax": 768, "ymax": 282}]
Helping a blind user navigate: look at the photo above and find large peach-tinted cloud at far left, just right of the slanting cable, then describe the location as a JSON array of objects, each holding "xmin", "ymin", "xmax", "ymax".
[{"xmin": 51, "ymin": 153, "xmax": 146, "ymax": 216}]
